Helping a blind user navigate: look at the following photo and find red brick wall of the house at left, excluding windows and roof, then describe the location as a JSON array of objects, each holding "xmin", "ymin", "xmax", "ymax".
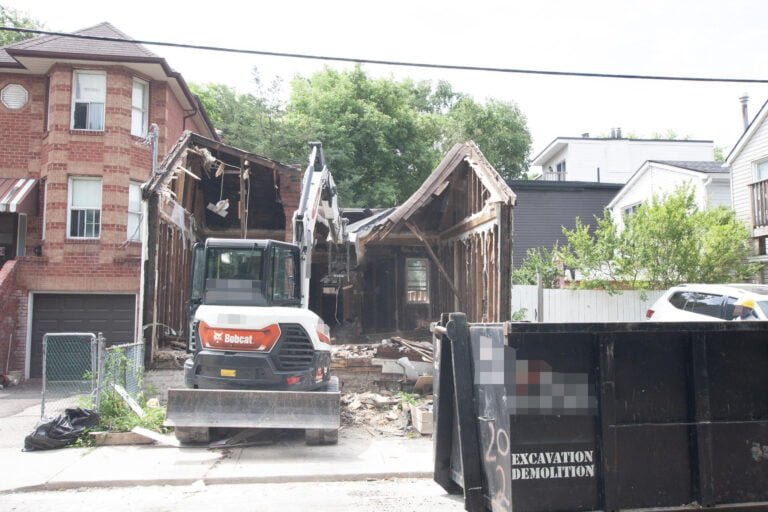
[{"xmin": 0, "ymin": 63, "xmax": 198, "ymax": 378}]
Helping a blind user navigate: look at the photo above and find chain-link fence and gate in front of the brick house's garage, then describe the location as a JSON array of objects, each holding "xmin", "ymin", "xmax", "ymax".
[{"xmin": 40, "ymin": 333, "xmax": 144, "ymax": 418}]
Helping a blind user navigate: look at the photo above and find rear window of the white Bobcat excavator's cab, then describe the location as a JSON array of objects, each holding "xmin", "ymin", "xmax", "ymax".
[{"xmin": 204, "ymin": 247, "xmax": 266, "ymax": 306}]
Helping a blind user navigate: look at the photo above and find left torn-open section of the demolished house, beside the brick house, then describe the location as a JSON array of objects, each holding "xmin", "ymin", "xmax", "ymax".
[{"xmin": 143, "ymin": 132, "xmax": 301, "ymax": 360}]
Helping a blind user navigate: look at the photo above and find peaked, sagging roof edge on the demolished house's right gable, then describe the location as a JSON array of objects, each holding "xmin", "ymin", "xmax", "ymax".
[{"xmin": 354, "ymin": 141, "xmax": 515, "ymax": 243}]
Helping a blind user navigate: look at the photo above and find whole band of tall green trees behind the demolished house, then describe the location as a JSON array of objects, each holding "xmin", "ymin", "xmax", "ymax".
[{"xmin": 193, "ymin": 66, "xmax": 530, "ymax": 207}]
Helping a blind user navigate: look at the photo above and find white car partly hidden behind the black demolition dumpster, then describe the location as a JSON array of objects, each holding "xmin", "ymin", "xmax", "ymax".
[{"xmin": 645, "ymin": 284, "xmax": 768, "ymax": 322}]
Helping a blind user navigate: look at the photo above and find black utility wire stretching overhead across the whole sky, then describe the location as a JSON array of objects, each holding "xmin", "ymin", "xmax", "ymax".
[{"xmin": 0, "ymin": 27, "xmax": 768, "ymax": 84}]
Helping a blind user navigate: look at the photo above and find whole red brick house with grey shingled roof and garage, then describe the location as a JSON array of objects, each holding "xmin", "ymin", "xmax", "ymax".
[{"xmin": 0, "ymin": 23, "xmax": 217, "ymax": 378}]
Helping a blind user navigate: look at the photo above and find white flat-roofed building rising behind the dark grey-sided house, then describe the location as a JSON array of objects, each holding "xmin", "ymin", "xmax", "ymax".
[{"xmin": 532, "ymin": 134, "xmax": 715, "ymax": 184}]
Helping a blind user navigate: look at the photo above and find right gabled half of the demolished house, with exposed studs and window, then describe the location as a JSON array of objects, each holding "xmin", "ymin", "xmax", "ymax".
[{"xmin": 342, "ymin": 142, "xmax": 515, "ymax": 333}]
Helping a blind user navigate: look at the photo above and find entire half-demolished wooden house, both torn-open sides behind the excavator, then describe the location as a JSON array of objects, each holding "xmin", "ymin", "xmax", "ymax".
[{"xmin": 143, "ymin": 136, "xmax": 515, "ymax": 361}]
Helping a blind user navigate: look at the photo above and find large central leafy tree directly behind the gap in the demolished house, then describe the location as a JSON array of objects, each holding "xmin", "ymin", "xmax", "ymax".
[{"xmin": 286, "ymin": 66, "xmax": 441, "ymax": 206}]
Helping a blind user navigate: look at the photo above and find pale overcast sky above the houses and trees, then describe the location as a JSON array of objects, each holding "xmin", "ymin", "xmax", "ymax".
[{"xmin": 6, "ymin": 0, "xmax": 768, "ymax": 162}]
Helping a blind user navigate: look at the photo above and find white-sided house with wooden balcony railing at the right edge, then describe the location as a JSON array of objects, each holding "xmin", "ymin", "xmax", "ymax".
[{"xmin": 726, "ymin": 98, "xmax": 768, "ymax": 282}]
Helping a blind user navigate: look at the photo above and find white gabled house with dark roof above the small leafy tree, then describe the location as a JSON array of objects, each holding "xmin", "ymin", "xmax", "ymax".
[{"xmin": 608, "ymin": 160, "xmax": 731, "ymax": 229}]
